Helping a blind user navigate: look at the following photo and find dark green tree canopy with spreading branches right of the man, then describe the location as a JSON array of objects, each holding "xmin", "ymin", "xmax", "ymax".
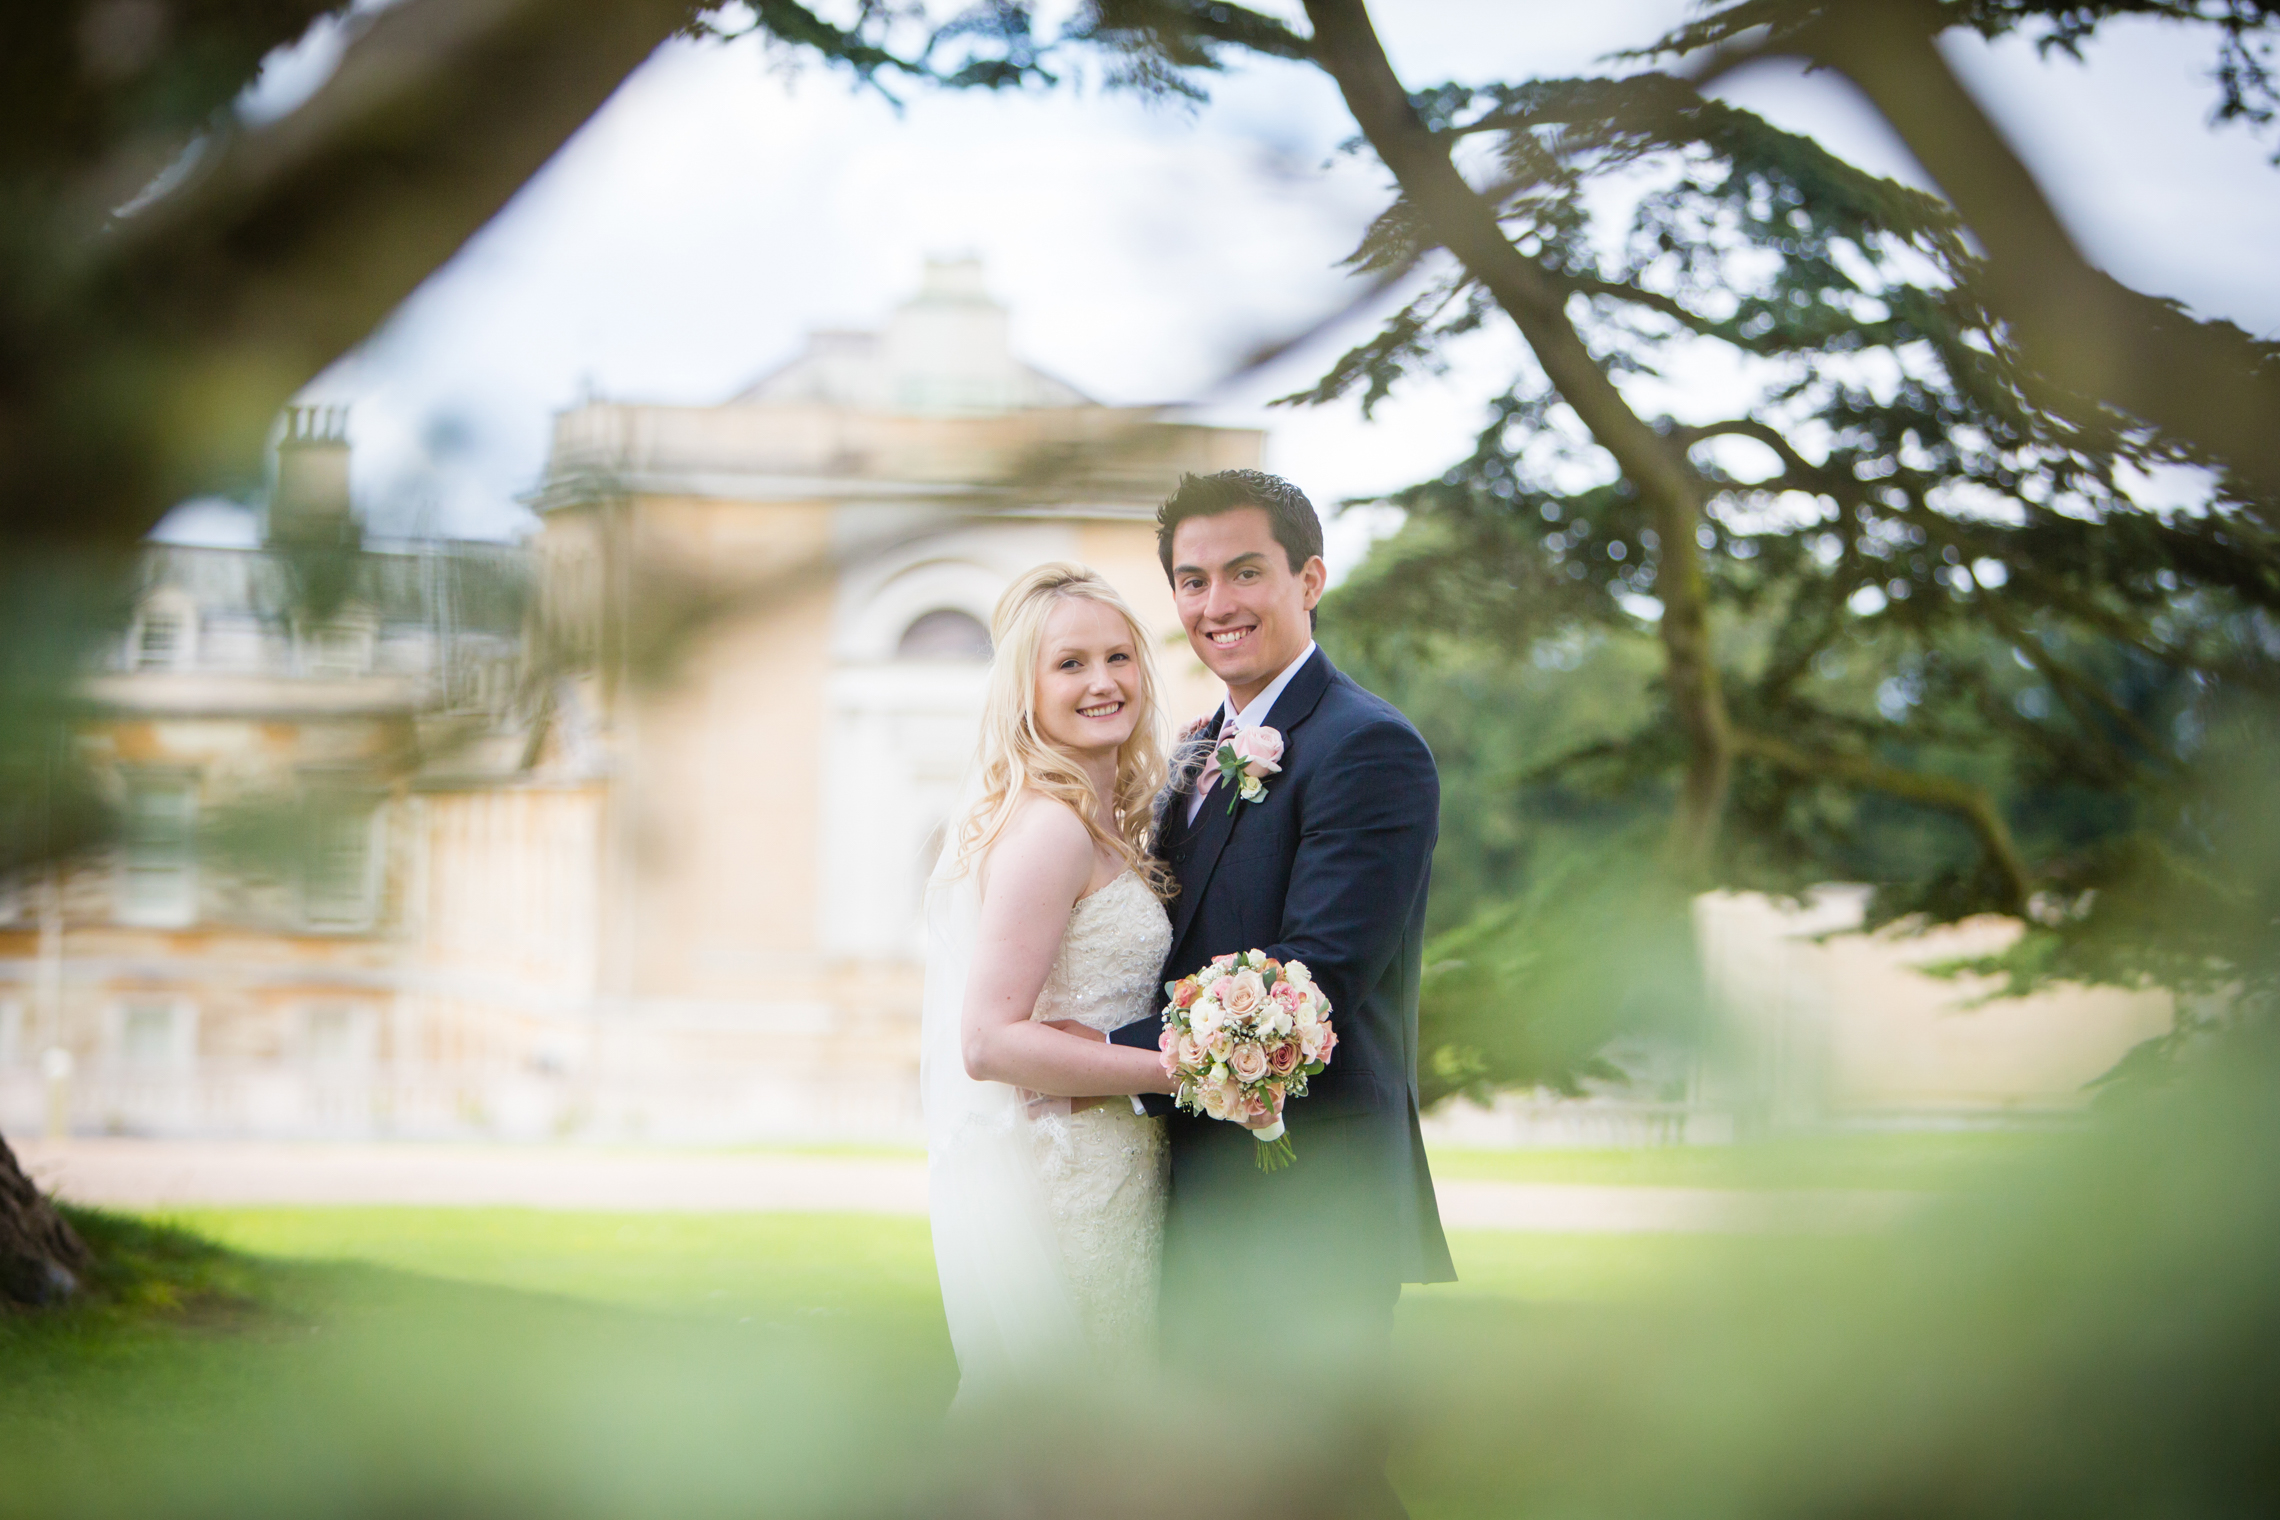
[{"xmin": 1293, "ymin": 5, "xmax": 2280, "ymax": 1093}]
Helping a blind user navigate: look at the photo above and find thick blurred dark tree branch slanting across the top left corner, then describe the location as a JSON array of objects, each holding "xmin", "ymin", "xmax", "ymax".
[{"xmin": 0, "ymin": 0, "xmax": 691, "ymax": 545}]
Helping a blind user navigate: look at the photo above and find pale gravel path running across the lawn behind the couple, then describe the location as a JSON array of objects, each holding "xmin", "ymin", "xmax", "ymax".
[{"xmin": 16, "ymin": 1139, "xmax": 1915, "ymax": 1233}]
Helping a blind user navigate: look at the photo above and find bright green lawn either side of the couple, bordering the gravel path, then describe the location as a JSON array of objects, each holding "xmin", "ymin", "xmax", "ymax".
[{"xmin": 0, "ymin": 1135, "xmax": 2020, "ymax": 1520}]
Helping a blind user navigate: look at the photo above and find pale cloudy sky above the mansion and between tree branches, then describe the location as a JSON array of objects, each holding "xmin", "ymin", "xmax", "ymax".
[{"xmin": 160, "ymin": 0, "xmax": 2280, "ymax": 572}]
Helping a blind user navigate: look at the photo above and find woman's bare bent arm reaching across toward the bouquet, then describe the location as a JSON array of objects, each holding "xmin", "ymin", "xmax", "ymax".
[{"xmin": 960, "ymin": 798, "xmax": 1172, "ymax": 1098}]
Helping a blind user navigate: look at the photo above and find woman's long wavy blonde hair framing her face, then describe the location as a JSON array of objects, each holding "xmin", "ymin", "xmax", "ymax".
[{"xmin": 955, "ymin": 563, "xmax": 1172, "ymax": 898}]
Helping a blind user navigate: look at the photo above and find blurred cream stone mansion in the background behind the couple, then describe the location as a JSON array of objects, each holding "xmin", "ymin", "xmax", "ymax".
[{"xmin": 0, "ymin": 260, "xmax": 2168, "ymax": 1142}]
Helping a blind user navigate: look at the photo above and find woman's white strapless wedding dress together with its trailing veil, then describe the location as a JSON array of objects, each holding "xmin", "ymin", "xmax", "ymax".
[{"xmin": 919, "ymin": 871, "xmax": 1172, "ymax": 1404}]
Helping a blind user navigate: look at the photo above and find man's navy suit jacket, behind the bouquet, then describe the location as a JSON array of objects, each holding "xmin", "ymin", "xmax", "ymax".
[{"xmin": 1117, "ymin": 649, "xmax": 1457, "ymax": 1292}]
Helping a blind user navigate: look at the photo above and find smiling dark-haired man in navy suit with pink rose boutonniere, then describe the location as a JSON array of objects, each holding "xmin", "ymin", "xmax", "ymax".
[{"xmin": 1117, "ymin": 469, "xmax": 1457, "ymax": 1412}]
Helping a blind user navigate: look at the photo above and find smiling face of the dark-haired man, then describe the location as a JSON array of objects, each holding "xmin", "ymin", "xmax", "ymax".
[{"xmin": 1172, "ymin": 506, "xmax": 1329, "ymax": 706}]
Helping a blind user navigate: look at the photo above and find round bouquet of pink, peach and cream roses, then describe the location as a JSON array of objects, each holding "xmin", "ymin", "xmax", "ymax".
[{"xmin": 1156, "ymin": 950, "xmax": 1338, "ymax": 1171}]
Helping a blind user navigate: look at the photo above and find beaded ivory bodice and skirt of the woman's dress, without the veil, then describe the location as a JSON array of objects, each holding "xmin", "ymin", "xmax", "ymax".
[{"xmin": 1031, "ymin": 871, "xmax": 1172, "ymax": 1356}]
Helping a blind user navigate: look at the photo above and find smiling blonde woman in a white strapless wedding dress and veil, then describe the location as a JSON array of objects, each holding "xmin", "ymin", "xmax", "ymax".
[{"xmin": 919, "ymin": 565, "xmax": 1172, "ymax": 1404}]
